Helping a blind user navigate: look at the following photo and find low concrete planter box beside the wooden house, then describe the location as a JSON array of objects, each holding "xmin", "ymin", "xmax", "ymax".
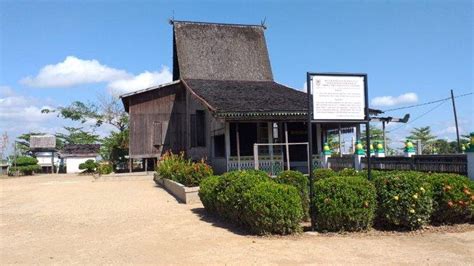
[{"xmin": 153, "ymin": 173, "xmax": 201, "ymax": 204}]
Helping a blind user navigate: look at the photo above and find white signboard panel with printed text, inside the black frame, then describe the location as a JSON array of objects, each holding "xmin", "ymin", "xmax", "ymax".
[{"xmin": 311, "ymin": 75, "xmax": 365, "ymax": 120}]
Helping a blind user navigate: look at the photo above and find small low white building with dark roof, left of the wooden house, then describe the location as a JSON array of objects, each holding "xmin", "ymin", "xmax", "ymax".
[{"xmin": 60, "ymin": 144, "xmax": 100, "ymax": 174}]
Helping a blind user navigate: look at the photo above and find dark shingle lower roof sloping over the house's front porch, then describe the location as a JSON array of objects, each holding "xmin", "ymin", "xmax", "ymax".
[{"xmin": 184, "ymin": 79, "xmax": 307, "ymax": 117}]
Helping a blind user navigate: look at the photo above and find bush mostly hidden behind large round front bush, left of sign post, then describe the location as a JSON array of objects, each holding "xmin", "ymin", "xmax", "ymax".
[{"xmin": 275, "ymin": 170, "xmax": 309, "ymax": 221}]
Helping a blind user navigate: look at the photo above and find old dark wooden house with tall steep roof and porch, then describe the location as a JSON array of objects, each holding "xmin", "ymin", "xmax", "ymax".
[{"xmin": 121, "ymin": 21, "xmax": 376, "ymax": 173}]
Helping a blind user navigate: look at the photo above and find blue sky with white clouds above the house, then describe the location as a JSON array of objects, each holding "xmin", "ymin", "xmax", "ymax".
[{"xmin": 0, "ymin": 0, "xmax": 474, "ymax": 151}]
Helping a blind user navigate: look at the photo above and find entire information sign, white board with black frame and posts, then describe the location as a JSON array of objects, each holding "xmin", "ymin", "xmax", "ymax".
[{"xmin": 306, "ymin": 72, "xmax": 371, "ymax": 230}]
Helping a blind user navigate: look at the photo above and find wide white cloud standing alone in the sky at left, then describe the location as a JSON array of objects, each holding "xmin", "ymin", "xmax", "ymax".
[{"xmin": 20, "ymin": 56, "xmax": 131, "ymax": 88}]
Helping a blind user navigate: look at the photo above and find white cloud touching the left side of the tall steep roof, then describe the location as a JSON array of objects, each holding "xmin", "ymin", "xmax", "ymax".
[{"xmin": 108, "ymin": 66, "xmax": 173, "ymax": 95}]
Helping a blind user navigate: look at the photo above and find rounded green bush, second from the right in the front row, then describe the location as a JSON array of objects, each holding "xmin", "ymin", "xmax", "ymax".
[{"xmin": 373, "ymin": 171, "xmax": 433, "ymax": 230}]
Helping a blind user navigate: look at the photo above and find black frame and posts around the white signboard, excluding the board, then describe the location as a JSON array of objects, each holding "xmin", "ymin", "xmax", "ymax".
[{"xmin": 306, "ymin": 72, "xmax": 372, "ymax": 231}]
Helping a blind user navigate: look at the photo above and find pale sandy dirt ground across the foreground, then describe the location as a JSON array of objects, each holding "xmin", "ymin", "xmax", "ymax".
[{"xmin": 0, "ymin": 175, "xmax": 474, "ymax": 265}]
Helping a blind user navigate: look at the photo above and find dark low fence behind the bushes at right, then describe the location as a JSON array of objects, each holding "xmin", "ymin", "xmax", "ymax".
[{"xmin": 329, "ymin": 154, "xmax": 467, "ymax": 175}]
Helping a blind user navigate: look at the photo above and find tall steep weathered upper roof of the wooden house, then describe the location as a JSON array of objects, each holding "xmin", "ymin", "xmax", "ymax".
[{"xmin": 172, "ymin": 21, "xmax": 273, "ymax": 81}]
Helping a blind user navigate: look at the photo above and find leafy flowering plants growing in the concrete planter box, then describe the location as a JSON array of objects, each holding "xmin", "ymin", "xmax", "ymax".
[{"xmin": 157, "ymin": 152, "xmax": 213, "ymax": 187}]
